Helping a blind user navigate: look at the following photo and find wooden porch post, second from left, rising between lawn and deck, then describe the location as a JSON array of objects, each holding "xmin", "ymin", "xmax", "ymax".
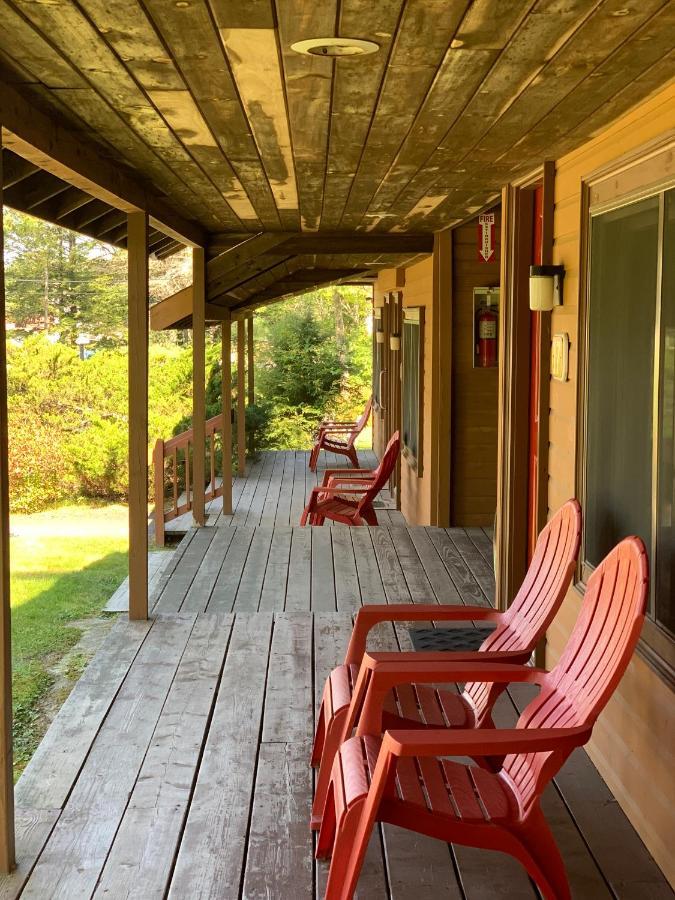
[{"xmin": 127, "ymin": 212, "xmax": 148, "ymax": 619}]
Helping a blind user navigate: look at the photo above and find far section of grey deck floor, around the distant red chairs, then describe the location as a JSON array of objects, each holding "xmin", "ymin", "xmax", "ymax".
[{"xmin": 166, "ymin": 450, "xmax": 405, "ymax": 534}]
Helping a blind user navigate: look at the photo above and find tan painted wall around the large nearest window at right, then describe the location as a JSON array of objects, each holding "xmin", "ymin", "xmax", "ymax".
[{"xmin": 547, "ymin": 81, "xmax": 675, "ymax": 883}]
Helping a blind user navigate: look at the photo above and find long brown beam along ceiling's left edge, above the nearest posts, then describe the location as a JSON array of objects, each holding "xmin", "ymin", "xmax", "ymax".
[{"xmin": 0, "ymin": 76, "xmax": 205, "ymax": 246}]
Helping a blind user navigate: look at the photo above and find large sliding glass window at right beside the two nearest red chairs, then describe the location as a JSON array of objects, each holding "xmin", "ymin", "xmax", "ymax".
[{"xmin": 584, "ymin": 179, "xmax": 675, "ymax": 684}]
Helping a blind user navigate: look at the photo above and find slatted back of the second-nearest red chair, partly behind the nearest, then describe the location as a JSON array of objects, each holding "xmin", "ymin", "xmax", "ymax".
[{"xmin": 464, "ymin": 500, "xmax": 581, "ymax": 724}]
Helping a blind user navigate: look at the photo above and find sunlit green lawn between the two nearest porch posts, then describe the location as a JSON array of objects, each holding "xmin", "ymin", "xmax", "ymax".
[{"xmin": 10, "ymin": 506, "xmax": 127, "ymax": 777}]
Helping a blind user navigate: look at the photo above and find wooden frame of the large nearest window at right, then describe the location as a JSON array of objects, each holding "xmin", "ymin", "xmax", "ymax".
[{"xmin": 575, "ymin": 135, "xmax": 675, "ymax": 690}]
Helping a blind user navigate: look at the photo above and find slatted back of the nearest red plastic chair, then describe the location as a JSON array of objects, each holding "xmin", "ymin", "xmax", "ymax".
[{"xmin": 502, "ymin": 537, "xmax": 649, "ymax": 812}]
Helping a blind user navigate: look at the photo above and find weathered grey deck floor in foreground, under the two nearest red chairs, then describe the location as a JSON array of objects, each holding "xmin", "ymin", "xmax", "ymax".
[{"xmin": 0, "ymin": 525, "xmax": 672, "ymax": 900}]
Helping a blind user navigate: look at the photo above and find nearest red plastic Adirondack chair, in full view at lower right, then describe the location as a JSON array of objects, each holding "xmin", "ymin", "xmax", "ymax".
[{"xmin": 317, "ymin": 537, "xmax": 649, "ymax": 900}]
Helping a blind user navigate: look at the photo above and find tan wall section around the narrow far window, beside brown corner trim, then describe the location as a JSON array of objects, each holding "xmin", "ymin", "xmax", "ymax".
[{"xmin": 401, "ymin": 257, "xmax": 434, "ymax": 525}]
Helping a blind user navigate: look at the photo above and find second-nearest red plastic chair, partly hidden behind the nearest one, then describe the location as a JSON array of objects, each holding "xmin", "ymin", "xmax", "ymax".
[{"xmin": 311, "ymin": 500, "xmax": 581, "ymax": 829}]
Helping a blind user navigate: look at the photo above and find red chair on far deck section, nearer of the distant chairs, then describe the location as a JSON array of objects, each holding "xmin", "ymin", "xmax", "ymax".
[{"xmin": 300, "ymin": 431, "xmax": 401, "ymax": 525}]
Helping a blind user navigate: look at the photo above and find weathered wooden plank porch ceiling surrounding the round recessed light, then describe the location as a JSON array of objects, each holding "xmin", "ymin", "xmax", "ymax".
[{"xmin": 0, "ymin": 0, "xmax": 675, "ymax": 253}]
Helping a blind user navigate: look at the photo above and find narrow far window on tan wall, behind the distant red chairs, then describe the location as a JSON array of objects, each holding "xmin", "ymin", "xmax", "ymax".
[{"xmin": 401, "ymin": 307, "xmax": 424, "ymax": 476}]
